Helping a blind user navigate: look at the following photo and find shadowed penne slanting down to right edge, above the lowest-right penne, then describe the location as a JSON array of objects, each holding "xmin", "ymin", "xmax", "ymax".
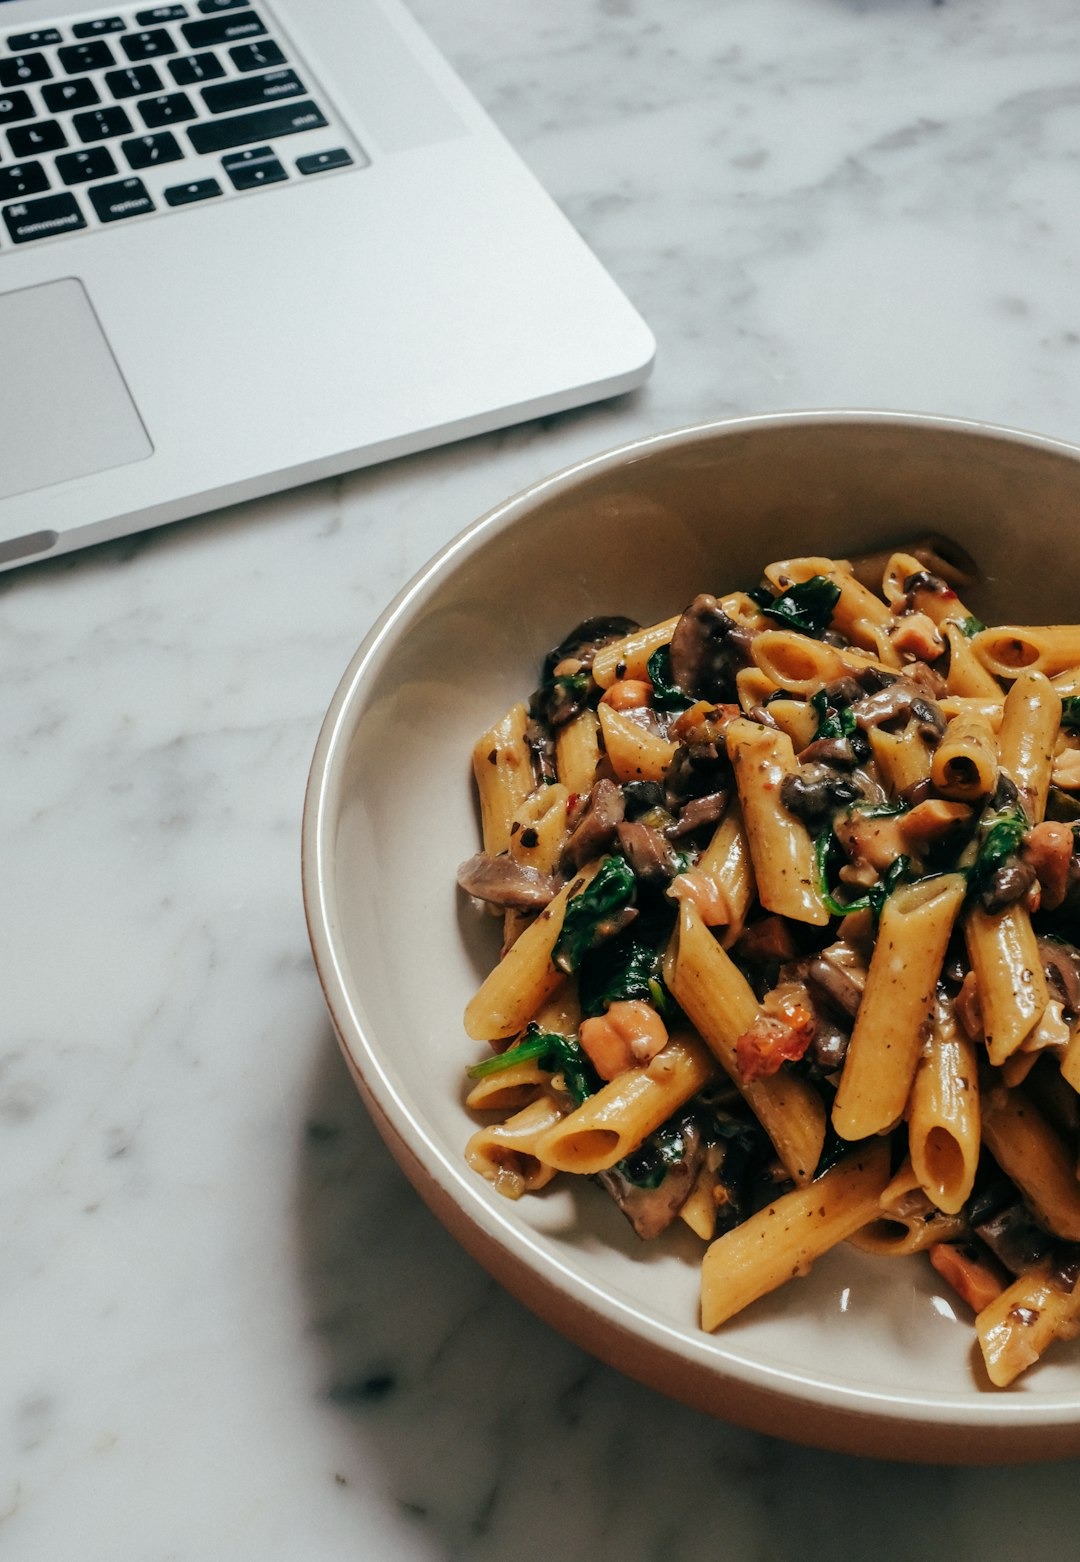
[{"xmin": 982, "ymin": 1086, "xmax": 1080, "ymax": 1242}]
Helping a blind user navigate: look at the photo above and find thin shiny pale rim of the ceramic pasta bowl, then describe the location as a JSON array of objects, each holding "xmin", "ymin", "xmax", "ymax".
[{"xmin": 302, "ymin": 409, "xmax": 1080, "ymax": 1462}]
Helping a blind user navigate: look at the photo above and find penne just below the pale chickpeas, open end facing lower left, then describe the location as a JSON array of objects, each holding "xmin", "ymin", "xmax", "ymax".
[{"xmin": 535, "ymin": 1031, "xmax": 716, "ymax": 1176}]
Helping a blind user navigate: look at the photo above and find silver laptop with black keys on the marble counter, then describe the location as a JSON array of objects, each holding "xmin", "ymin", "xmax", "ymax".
[{"xmin": 0, "ymin": 0, "xmax": 655, "ymax": 569}]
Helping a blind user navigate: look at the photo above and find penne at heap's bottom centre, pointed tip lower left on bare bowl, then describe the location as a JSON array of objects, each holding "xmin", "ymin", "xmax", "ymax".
[{"xmin": 702, "ymin": 1140, "xmax": 889, "ymax": 1332}]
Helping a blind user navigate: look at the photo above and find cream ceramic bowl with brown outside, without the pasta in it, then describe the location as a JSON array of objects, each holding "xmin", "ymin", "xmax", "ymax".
[{"xmin": 303, "ymin": 412, "xmax": 1080, "ymax": 1462}]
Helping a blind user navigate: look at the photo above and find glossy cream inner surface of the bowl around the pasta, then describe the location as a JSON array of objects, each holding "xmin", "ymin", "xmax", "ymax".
[{"xmin": 322, "ymin": 420, "xmax": 1080, "ymax": 1424}]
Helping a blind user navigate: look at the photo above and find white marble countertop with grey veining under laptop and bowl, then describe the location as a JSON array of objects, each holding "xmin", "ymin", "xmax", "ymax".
[{"xmin": 0, "ymin": 0, "xmax": 1080, "ymax": 1562}]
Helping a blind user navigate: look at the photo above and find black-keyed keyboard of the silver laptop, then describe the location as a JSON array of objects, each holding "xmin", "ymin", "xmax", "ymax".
[{"xmin": 0, "ymin": 0, "xmax": 367, "ymax": 245}]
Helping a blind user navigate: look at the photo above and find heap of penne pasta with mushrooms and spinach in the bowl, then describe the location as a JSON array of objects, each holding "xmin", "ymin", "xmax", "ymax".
[{"xmin": 458, "ymin": 542, "xmax": 1080, "ymax": 1387}]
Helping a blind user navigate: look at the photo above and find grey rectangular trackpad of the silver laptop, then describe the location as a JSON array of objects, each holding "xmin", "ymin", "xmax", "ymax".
[{"xmin": 0, "ymin": 276, "xmax": 153, "ymax": 498}]
